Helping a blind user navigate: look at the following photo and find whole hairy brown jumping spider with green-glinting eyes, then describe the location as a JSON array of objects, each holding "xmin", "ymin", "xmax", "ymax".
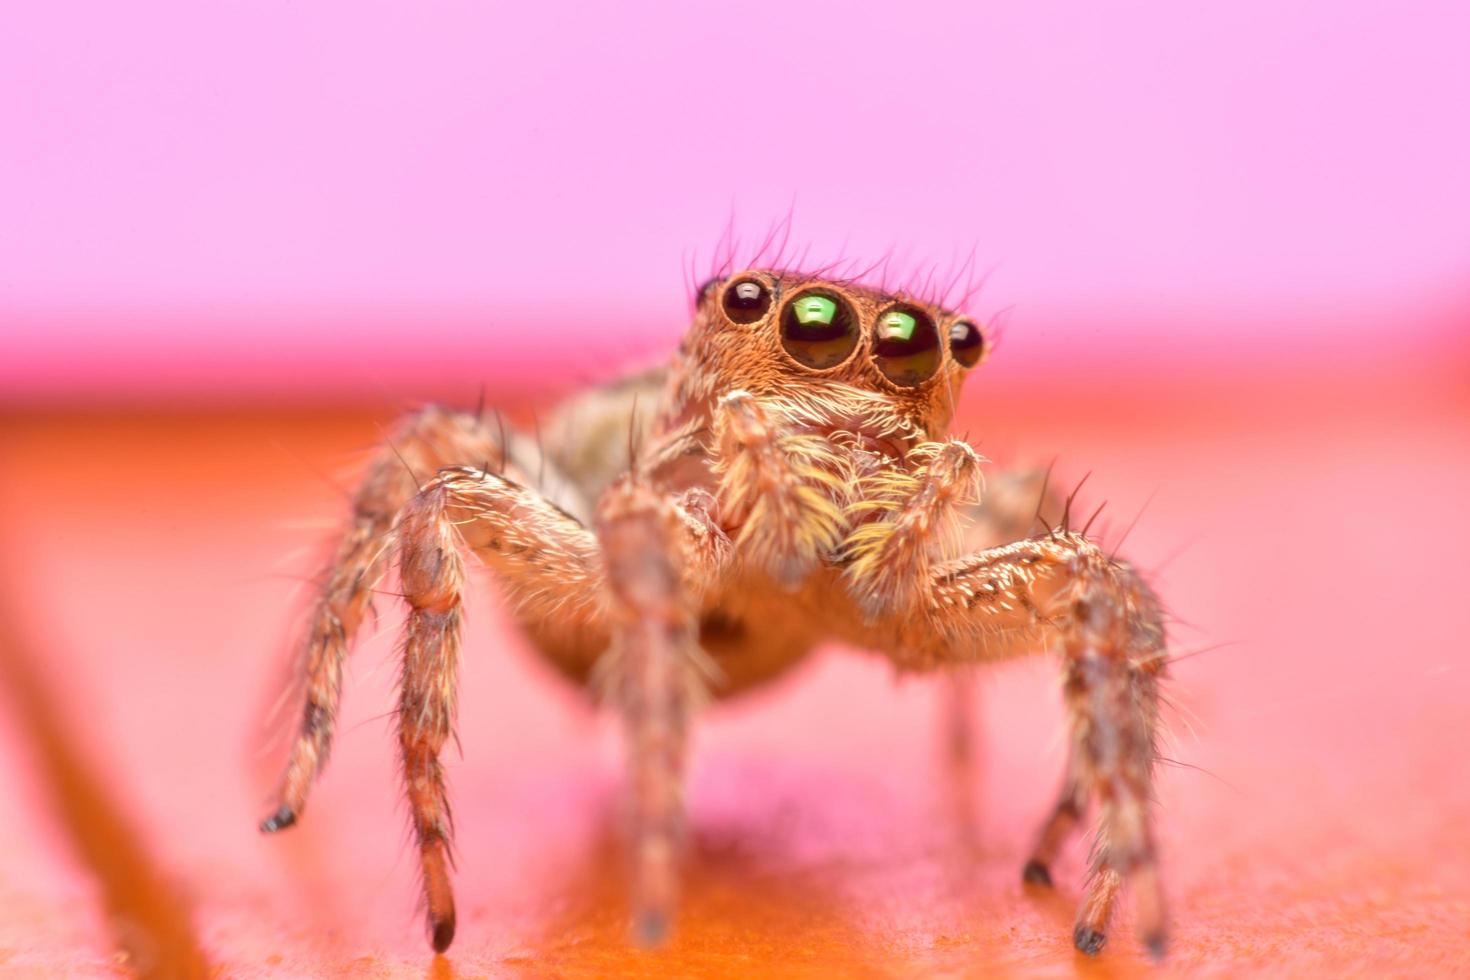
[{"xmin": 262, "ymin": 269, "xmax": 1167, "ymax": 955}]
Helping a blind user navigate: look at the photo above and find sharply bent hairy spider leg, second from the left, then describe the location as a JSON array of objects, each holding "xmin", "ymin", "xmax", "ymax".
[{"xmin": 397, "ymin": 467, "xmax": 607, "ymax": 952}]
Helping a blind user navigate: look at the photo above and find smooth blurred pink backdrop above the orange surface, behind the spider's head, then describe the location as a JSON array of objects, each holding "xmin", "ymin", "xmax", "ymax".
[{"xmin": 0, "ymin": 0, "xmax": 1470, "ymax": 401}]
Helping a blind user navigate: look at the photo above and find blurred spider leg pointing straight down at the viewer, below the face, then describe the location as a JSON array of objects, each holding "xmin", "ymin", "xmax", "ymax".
[{"xmin": 597, "ymin": 478, "xmax": 729, "ymax": 946}]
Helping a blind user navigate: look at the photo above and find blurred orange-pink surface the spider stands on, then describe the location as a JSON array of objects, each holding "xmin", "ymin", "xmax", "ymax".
[{"xmin": 0, "ymin": 366, "xmax": 1470, "ymax": 977}]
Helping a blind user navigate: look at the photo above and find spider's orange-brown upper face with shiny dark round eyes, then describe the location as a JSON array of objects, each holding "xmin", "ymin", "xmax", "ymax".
[{"xmin": 685, "ymin": 269, "xmax": 989, "ymax": 432}]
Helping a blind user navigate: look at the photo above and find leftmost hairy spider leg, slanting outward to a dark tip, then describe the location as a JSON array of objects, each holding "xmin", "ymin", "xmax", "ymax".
[{"xmin": 260, "ymin": 407, "xmax": 517, "ymax": 833}]
